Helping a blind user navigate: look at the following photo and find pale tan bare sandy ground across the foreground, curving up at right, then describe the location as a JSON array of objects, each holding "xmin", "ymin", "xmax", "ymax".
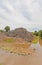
[{"xmin": 0, "ymin": 44, "xmax": 42, "ymax": 65}]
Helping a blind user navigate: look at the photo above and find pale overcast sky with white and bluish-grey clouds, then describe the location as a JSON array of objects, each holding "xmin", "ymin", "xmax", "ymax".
[{"xmin": 0, "ymin": 0, "xmax": 42, "ymax": 31}]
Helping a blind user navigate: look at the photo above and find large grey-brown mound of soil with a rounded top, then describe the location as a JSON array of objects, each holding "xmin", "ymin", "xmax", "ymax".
[{"xmin": 7, "ymin": 28, "xmax": 34, "ymax": 42}]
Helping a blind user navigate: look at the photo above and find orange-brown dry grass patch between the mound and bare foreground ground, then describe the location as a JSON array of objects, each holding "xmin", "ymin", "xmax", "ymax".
[{"xmin": 0, "ymin": 38, "xmax": 32, "ymax": 55}]
